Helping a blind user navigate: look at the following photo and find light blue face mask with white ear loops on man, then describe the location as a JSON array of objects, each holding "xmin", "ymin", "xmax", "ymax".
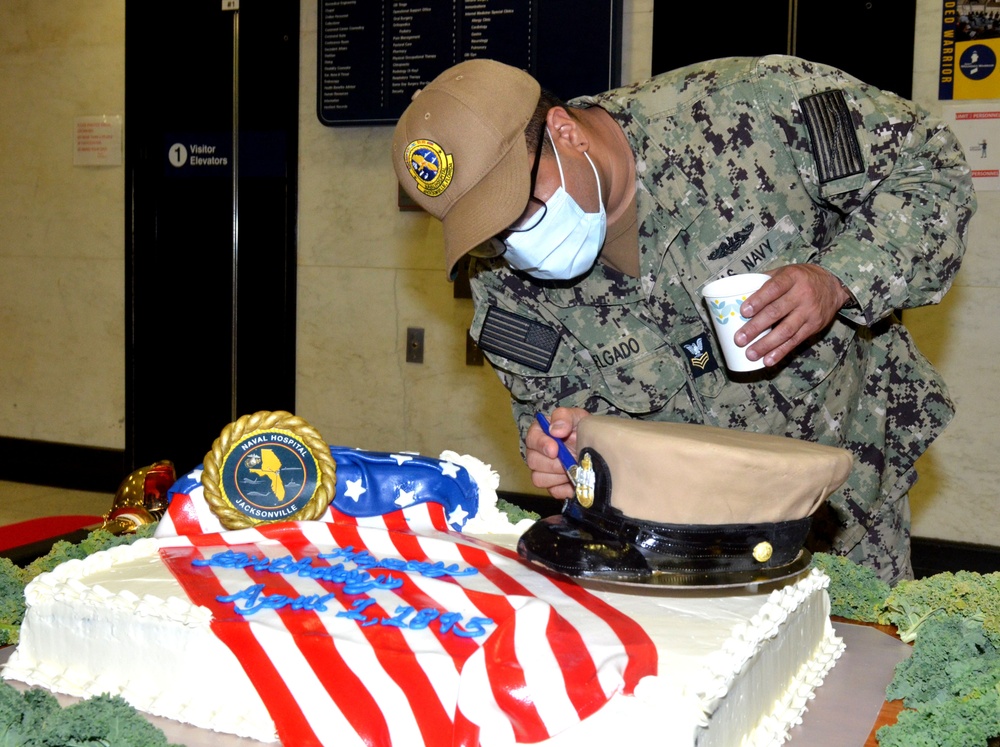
[{"xmin": 504, "ymin": 127, "xmax": 608, "ymax": 280}]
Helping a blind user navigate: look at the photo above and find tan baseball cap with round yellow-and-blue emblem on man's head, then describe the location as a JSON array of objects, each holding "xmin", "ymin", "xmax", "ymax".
[{"xmin": 392, "ymin": 59, "xmax": 541, "ymax": 275}]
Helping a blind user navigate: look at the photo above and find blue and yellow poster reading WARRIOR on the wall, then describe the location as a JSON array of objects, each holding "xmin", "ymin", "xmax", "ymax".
[{"xmin": 938, "ymin": 0, "xmax": 1000, "ymax": 99}]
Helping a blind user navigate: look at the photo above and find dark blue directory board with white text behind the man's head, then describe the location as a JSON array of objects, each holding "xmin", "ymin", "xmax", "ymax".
[{"xmin": 317, "ymin": 0, "xmax": 622, "ymax": 126}]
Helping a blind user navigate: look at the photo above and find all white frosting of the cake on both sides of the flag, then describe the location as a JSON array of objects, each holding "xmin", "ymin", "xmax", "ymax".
[{"xmin": 3, "ymin": 528, "xmax": 843, "ymax": 747}]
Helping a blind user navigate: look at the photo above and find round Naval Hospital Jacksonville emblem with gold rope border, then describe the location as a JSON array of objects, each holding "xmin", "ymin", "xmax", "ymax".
[{"xmin": 201, "ymin": 410, "xmax": 336, "ymax": 529}]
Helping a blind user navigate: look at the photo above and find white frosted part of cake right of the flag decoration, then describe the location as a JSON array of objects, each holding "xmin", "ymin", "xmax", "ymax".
[{"xmin": 524, "ymin": 571, "xmax": 844, "ymax": 747}]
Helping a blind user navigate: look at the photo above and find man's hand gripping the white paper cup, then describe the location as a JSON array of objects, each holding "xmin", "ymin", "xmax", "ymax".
[{"xmin": 735, "ymin": 264, "xmax": 851, "ymax": 366}]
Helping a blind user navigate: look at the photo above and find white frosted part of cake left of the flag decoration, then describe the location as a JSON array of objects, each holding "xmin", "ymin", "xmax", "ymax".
[{"xmin": 3, "ymin": 539, "xmax": 276, "ymax": 741}]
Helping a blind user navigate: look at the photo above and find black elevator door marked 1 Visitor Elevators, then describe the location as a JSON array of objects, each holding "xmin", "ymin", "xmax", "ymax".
[{"xmin": 125, "ymin": 0, "xmax": 299, "ymax": 471}]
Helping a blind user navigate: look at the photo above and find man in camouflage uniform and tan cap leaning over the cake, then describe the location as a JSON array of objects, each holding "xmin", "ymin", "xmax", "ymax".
[{"xmin": 393, "ymin": 56, "xmax": 975, "ymax": 582}]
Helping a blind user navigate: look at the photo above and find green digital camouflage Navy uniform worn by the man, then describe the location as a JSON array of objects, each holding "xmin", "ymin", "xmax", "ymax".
[{"xmin": 470, "ymin": 56, "xmax": 976, "ymax": 581}]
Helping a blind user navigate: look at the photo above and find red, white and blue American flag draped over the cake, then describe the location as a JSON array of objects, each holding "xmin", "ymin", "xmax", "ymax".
[{"xmin": 148, "ymin": 414, "xmax": 657, "ymax": 747}]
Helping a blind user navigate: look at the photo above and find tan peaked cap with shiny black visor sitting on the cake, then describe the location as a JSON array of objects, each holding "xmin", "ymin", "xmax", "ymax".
[{"xmin": 518, "ymin": 415, "xmax": 853, "ymax": 586}]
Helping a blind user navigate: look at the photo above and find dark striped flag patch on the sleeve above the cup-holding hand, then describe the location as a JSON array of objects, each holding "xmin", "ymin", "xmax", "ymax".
[{"xmin": 800, "ymin": 90, "xmax": 865, "ymax": 184}]
